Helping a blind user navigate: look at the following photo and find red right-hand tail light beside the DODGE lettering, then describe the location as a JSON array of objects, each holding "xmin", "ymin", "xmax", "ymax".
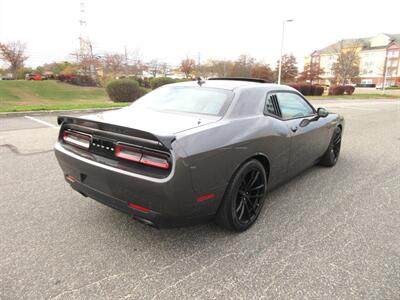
[{"xmin": 115, "ymin": 144, "xmax": 170, "ymax": 169}]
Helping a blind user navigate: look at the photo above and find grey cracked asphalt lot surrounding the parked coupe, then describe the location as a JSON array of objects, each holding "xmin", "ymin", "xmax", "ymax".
[{"xmin": 0, "ymin": 100, "xmax": 400, "ymax": 299}]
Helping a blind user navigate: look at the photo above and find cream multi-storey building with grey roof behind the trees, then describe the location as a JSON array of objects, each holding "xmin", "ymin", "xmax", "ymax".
[{"xmin": 305, "ymin": 33, "xmax": 400, "ymax": 86}]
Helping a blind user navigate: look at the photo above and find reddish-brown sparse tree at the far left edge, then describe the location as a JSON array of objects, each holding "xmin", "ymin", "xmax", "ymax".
[{"xmin": 0, "ymin": 41, "xmax": 28, "ymax": 78}]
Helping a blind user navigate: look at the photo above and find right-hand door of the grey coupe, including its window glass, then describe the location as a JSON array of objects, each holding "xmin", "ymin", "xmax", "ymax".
[{"xmin": 276, "ymin": 91, "xmax": 328, "ymax": 176}]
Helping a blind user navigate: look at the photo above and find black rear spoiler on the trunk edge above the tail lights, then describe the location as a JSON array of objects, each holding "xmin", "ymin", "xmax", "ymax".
[{"xmin": 57, "ymin": 116, "xmax": 175, "ymax": 150}]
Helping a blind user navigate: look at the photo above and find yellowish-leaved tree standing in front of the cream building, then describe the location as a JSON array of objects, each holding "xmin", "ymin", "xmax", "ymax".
[{"xmin": 332, "ymin": 40, "xmax": 362, "ymax": 84}]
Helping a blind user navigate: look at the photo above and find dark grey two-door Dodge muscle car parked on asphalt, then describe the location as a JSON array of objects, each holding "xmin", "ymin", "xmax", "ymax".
[{"xmin": 55, "ymin": 79, "xmax": 344, "ymax": 231}]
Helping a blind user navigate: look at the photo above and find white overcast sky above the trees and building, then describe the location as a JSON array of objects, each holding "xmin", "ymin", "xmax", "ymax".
[{"xmin": 0, "ymin": 0, "xmax": 400, "ymax": 66}]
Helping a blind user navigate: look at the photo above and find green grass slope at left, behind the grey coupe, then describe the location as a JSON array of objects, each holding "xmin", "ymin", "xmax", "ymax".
[{"xmin": 0, "ymin": 80, "xmax": 129, "ymax": 112}]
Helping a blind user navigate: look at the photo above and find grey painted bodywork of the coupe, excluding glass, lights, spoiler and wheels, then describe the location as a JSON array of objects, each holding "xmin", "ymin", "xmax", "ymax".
[{"xmin": 56, "ymin": 81, "xmax": 344, "ymax": 223}]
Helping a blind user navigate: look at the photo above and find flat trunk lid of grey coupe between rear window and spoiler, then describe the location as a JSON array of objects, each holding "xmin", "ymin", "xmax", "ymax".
[{"xmin": 83, "ymin": 107, "xmax": 221, "ymax": 135}]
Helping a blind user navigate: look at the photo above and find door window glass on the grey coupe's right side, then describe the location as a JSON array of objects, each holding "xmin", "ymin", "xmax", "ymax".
[{"xmin": 276, "ymin": 92, "xmax": 314, "ymax": 120}]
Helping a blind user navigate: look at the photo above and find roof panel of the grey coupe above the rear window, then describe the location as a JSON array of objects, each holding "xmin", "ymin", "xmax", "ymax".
[{"xmin": 171, "ymin": 80, "xmax": 291, "ymax": 91}]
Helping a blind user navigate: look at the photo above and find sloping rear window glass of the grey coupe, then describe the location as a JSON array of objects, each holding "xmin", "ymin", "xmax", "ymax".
[{"xmin": 131, "ymin": 86, "xmax": 233, "ymax": 116}]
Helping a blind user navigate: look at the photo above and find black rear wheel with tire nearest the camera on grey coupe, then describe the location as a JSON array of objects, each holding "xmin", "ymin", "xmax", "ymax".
[{"xmin": 216, "ymin": 159, "xmax": 267, "ymax": 232}]
